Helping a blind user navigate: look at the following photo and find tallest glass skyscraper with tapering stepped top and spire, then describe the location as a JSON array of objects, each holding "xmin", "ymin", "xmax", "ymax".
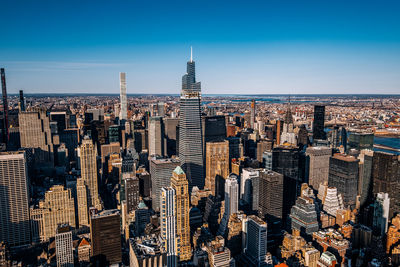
[{"xmin": 179, "ymin": 48, "xmax": 204, "ymax": 191}]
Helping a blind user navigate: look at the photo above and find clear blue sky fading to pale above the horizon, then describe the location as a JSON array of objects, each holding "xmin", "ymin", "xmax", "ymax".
[{"xmin": 0, "ymin": 0, "xmax": 400, "ymax": 94}]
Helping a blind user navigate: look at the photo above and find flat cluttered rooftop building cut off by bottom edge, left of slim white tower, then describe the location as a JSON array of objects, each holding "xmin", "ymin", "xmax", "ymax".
[{"xmin": 129, "ymin": 235, "xmax": 167, "ymax": 267}]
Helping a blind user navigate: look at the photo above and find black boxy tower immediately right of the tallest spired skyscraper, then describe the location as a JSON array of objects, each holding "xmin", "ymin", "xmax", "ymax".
[{"xmin": 203, "ymin": 115, "xmax": 226, "ymax": 143}]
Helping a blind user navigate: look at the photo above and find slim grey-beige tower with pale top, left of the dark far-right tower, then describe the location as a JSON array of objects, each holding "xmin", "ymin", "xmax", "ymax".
[{"xmin": 358, "ymin": 149, "xmax": 374, "ymax": 207}]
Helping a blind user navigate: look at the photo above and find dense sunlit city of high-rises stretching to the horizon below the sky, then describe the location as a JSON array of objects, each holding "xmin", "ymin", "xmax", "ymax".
[{"xmin": 0, "ymin": 0, "xmax": 400, "ymax": 267}]
